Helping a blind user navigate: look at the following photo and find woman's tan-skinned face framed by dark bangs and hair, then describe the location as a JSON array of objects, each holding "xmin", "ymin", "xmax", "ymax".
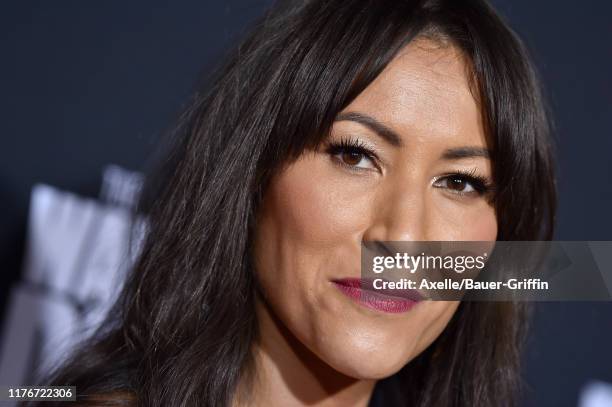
[{"xmin": 255, "ymin": 39, "xmax": 497, "ymax": 379}]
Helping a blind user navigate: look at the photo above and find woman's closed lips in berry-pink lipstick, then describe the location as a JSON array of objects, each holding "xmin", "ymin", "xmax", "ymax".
[{"xmin": 332, "ymin": 278, "xmax": 424, "ymax": 314}]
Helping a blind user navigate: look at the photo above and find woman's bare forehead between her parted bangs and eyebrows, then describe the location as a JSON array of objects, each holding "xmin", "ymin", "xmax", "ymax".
[{"xmin": 345, "ymin": 39, "xmax": 486, "ymax": 147}]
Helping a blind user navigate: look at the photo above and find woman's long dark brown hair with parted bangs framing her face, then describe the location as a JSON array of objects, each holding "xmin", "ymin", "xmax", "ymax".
[{"xmin": 31, "ymin": 0, "xmax": 556, "ymax": 407}]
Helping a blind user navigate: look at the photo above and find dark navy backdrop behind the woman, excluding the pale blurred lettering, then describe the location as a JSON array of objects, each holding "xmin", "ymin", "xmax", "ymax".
[{"xmin": 0, "ymin": 0, "xmax": 612, "ymax": 407}]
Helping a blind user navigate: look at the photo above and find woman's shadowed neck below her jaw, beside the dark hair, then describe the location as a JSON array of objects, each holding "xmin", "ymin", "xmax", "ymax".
[{"xmin": 233, "ymin": 299, "xmax": 376, "ymax": 407}]
